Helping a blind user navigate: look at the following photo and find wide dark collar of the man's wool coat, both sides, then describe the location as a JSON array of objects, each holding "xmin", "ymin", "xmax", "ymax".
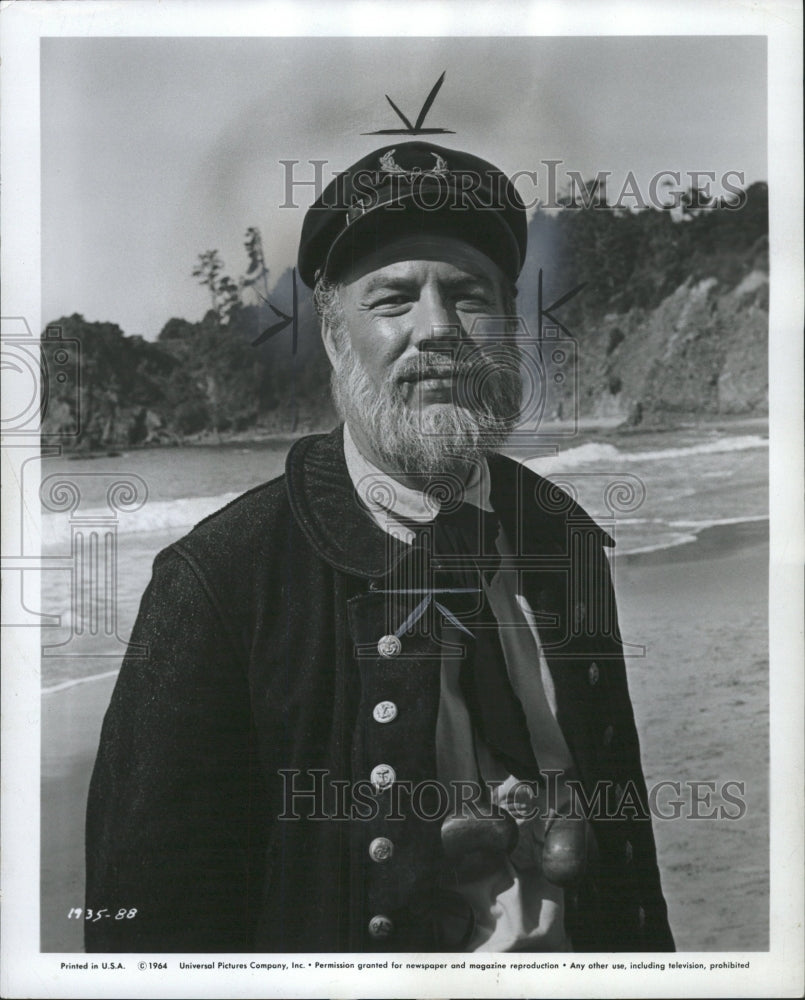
[{"xmin": 285, "ymin": 427, "xmax": 615, "ymax": 578}]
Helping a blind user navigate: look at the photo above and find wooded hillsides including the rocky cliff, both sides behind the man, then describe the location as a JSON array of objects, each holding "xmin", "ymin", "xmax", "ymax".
[{"xmin": 43, "ymin": 184, "xmax": 768, "ymax": 449}]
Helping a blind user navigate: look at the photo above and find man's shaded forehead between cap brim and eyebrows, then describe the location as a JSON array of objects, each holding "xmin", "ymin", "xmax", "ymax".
[{"xmin": 340, "ymin": 234, "xmax": 504, "ymax": 287}]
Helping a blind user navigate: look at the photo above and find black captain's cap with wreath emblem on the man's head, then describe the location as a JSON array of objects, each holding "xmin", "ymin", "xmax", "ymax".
[{"xmin": 298, "ymin": 142, "xmax": 527, "ymax": 288}]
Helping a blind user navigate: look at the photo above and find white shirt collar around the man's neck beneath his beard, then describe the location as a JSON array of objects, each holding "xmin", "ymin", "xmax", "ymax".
[{"xmin": 344, "ymin": 424, "xmax": 492, "ymax": 542}]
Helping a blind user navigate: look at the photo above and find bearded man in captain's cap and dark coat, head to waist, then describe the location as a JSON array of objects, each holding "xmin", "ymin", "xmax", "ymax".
[{"xmin": 86, "ymin": 142, "xmax": 673, "ymax": 952}]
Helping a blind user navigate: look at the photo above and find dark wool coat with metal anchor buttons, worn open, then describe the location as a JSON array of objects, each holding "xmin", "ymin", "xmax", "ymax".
[{"xmin": 86, "ymin": 429, "xmax": 673, "ymax": 952}]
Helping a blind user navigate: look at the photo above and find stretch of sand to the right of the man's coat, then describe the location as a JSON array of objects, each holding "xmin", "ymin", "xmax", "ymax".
[{"xmin": 616, "ymin": 537, "xmax": 769, "ymax": 951}]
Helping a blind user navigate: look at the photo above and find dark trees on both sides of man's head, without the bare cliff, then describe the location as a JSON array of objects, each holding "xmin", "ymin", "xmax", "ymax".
[{"xmin": 45, "ymin": 183, "xmax": 768, "ymax": 447}]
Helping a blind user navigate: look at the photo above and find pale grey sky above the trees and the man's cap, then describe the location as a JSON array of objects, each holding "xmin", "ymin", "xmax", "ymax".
[{"xmin": 40, "ymin": 36, "xmax": 767, "ymax": 339}]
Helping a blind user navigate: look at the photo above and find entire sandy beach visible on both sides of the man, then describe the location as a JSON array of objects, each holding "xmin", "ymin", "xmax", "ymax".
[{"xmin": 41, "ymin": 529, "xmax": 769, "ymax": 952}]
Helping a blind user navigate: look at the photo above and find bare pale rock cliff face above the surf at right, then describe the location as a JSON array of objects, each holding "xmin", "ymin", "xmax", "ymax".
[{"xmin": 578, "ymin": 249, "xmax": 769, "ymax": 424}]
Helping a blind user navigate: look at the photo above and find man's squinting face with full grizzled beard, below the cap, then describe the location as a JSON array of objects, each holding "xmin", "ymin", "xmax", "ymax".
[{"xmin": 324, "ymin": 237, "xmax": 521, "ymax": 473}]
